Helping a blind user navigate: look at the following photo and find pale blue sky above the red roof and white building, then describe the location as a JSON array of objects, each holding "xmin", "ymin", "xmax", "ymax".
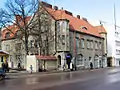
[{"xmin": 0, "ymin": 0, "xmax": 120, "ymax": 26}]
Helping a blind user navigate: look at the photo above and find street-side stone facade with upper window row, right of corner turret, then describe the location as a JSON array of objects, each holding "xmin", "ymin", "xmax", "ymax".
[{"xmin": 70, "ymin": 32, "xmax": 107, "ymax": 68}]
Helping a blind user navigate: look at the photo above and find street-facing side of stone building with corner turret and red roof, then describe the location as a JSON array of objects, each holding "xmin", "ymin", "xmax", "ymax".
[{"xmin": 33, "ymin": 3, "xmax": 107, "ymax": 69}]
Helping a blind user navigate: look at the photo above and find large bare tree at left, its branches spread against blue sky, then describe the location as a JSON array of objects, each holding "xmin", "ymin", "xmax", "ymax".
[{"xmin": 0, "ymin": 0, "xmax": 38, "ymax": 54}]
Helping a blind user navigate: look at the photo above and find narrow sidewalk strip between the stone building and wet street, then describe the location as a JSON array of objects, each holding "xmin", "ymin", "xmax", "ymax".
[{"xmin": 6, "ymin": 67, "xmax": 116, "ymax": 77}]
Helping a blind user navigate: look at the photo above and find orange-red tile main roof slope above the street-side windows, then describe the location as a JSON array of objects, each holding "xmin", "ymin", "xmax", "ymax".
[{"xmin": 45, "ymin": 7, "xmax": 103, "ymax": 38}]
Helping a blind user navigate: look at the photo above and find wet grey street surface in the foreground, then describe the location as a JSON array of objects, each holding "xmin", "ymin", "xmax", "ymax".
[{"xmin": 0, "ymin": 67, "xmax": 120, "ymax": 90}]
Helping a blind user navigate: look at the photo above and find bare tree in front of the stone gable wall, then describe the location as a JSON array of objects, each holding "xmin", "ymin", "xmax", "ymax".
[{"xmin": 30, "ymin": 2, "xmax": 55, "ymax": 55}]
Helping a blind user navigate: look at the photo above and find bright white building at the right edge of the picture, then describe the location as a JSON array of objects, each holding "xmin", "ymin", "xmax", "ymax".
[{"xmin": 101, "ymin": 23, "xmax": 120, "ymax": 66}]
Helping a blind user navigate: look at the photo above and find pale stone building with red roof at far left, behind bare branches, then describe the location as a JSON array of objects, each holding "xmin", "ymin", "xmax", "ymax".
[{"xmin": 1, "ymin": 15, "xmax": 30, "ymax": 68}]
